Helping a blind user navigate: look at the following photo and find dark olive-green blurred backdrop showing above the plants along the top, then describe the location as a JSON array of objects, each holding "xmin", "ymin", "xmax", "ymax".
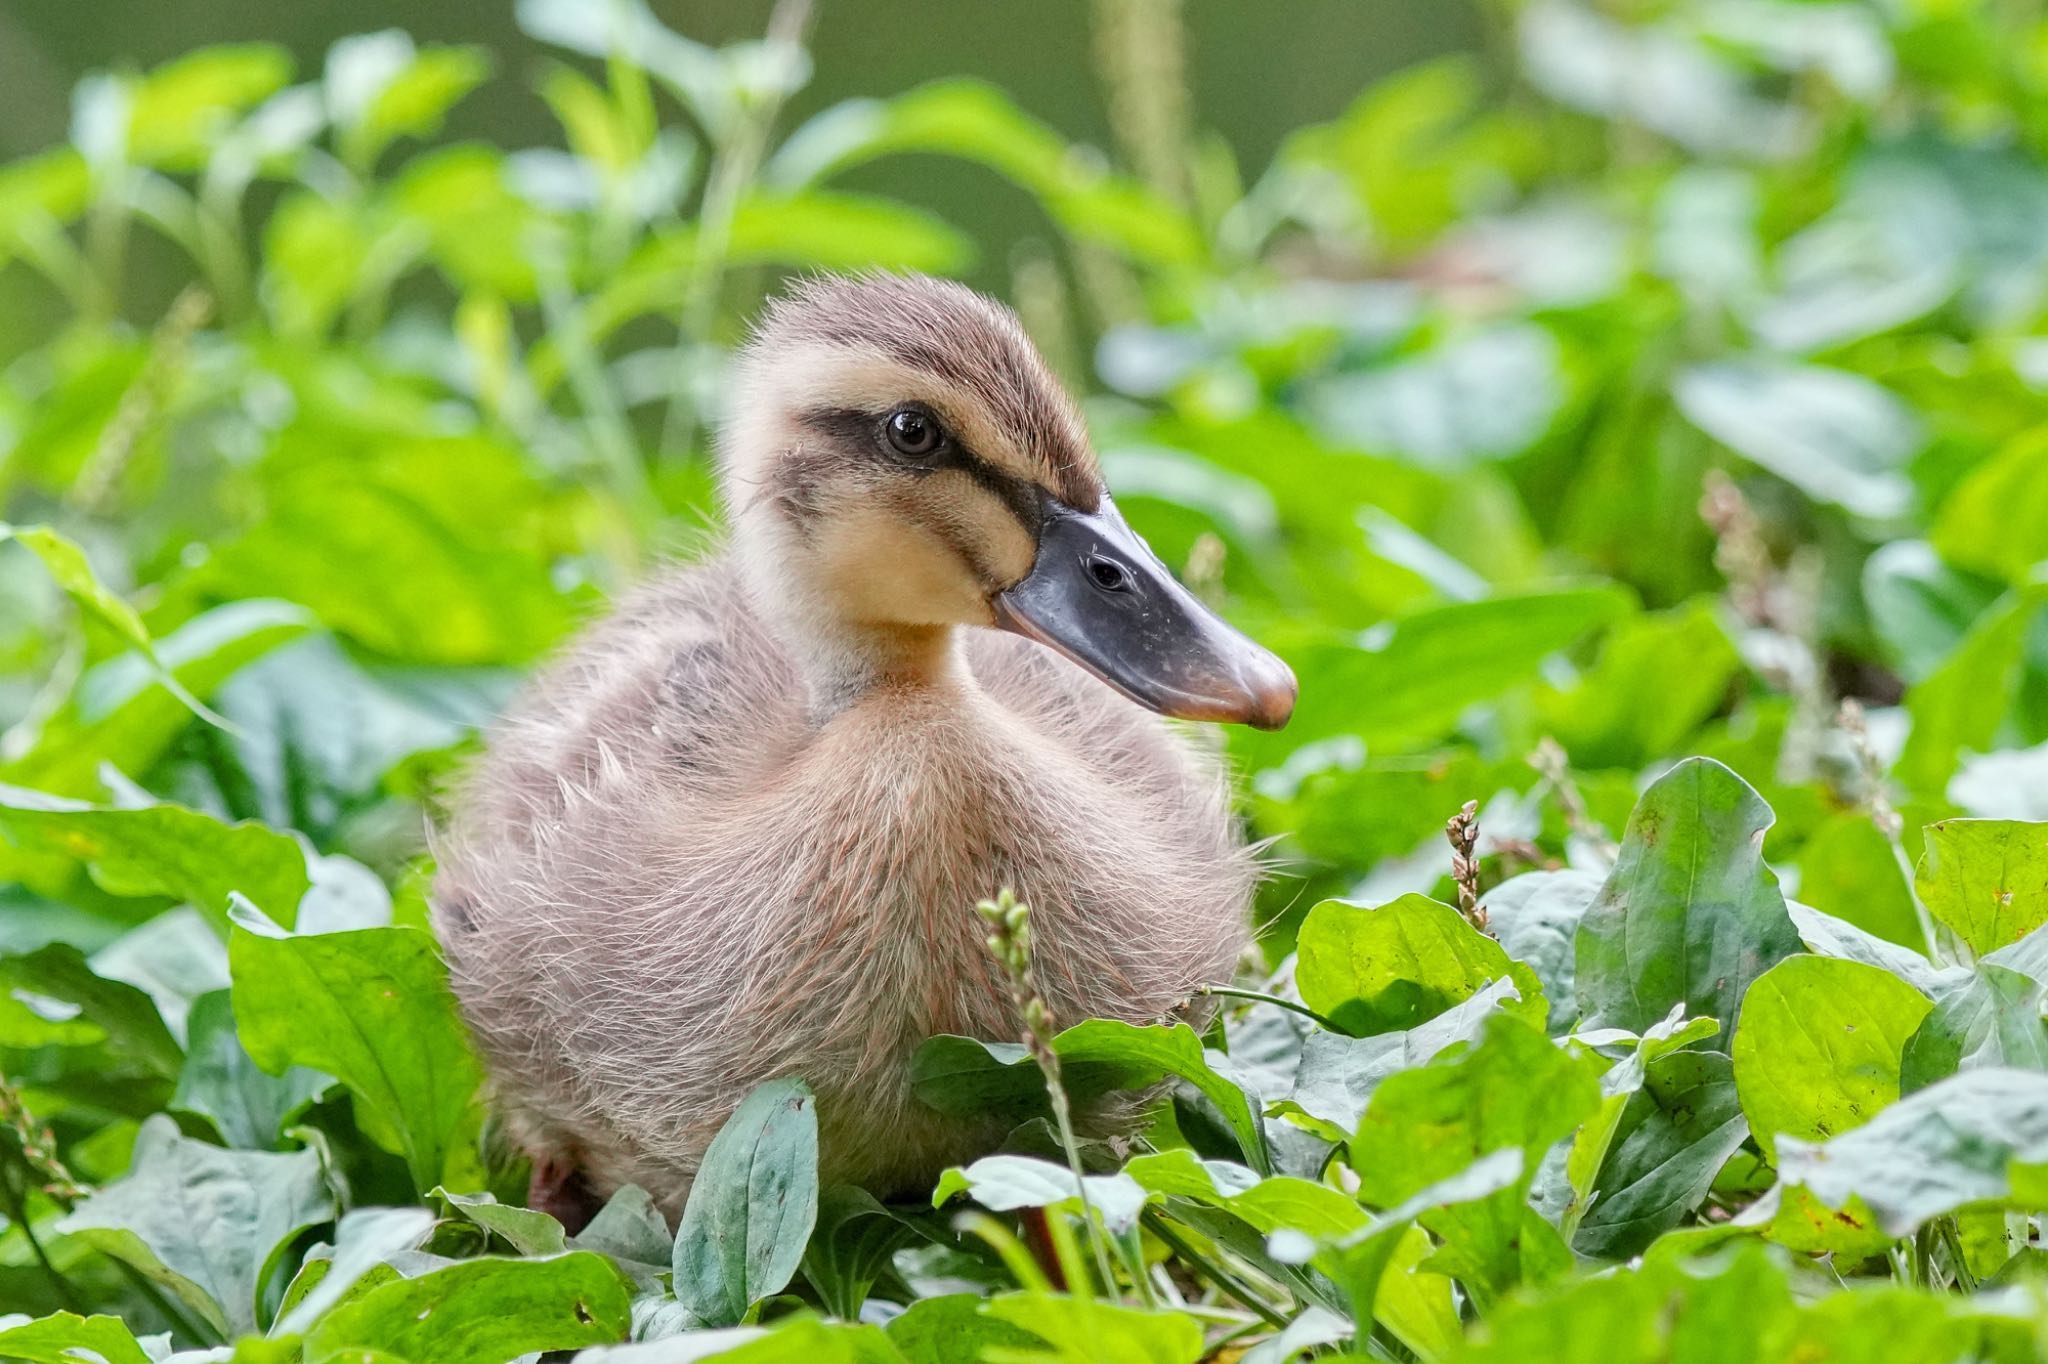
[{"xmin": 0, "ymin": 0, "xmax": 1481, "ymax": 311}]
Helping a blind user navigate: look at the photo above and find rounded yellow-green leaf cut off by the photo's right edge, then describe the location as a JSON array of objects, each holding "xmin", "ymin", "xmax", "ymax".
[{"xmin": 1915, "ymin": 819, "xmax": 2048, "ymax": 956}]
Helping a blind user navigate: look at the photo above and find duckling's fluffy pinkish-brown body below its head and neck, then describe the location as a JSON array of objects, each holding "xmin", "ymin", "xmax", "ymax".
[{"xmin": 434, "ymin": 557, "xmax": 1255, "ymax": 1210}]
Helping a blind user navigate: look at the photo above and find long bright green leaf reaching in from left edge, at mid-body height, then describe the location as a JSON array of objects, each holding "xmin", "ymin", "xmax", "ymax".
[{"xmin": 0, "ymin": 786, "xmax": 311, "ymax": 928}]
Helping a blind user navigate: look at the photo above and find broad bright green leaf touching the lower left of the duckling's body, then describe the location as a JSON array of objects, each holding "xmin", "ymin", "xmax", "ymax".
[{"xmin": 227, "ymin": 926, "xmax": 483, "ymax": 1192}]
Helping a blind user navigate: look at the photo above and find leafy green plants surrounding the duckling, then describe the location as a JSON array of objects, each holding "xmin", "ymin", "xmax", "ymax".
[{"xmin": 0, "ymin": 0, "xmax": 2048, "ymax": 1364}]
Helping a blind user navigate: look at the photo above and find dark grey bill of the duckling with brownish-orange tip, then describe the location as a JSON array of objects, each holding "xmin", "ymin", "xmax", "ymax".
[{"xmin": 993, "ymin": 496, "xmax": 1296, "ymax": 729}]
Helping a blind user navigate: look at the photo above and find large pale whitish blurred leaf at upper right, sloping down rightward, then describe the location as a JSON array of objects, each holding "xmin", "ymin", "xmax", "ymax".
[{"xmin": 1671, "ymin": 358, "xmax": 1927, "ymax": 520}]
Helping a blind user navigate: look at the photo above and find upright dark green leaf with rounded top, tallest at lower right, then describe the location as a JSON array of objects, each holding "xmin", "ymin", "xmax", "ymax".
[{"xmin": 1575, "ymin": 758, "xmax": 1800, "ymax": 1036}]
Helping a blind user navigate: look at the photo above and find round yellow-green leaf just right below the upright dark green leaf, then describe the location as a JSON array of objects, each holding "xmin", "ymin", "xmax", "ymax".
[{"xmin": 1731, "ymin": 956, "xmax": 1933, "ymax": 1159}]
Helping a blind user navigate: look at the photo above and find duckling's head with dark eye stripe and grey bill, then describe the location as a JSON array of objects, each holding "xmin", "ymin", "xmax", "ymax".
[{"xmin": 721, "ymin": 274, "xmax": 1294, "ymax": 729}]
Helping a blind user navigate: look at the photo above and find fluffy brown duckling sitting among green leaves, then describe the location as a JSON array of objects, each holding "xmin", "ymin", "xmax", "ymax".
[{"xmin": 434, "ymin": 274, "xmax": 1294, "ymax": 1225}]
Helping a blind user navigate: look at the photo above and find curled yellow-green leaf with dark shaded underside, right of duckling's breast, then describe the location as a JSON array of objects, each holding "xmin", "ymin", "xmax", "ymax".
[{"xmin": 1294, "ymin": 895, "xmax": 1546, "ymax": 1036}]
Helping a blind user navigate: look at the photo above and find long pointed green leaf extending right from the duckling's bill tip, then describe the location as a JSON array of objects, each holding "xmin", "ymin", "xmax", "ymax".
[{"xmin": 1262, "ymin": 586, "xmax": 1630, "ymax": 749}]
